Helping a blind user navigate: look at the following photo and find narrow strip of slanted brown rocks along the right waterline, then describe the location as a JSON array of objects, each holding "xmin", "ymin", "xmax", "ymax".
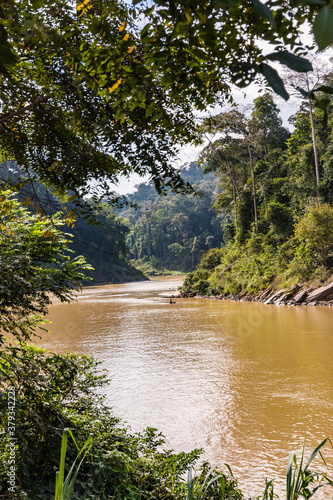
[{"xmin": 182, "ymin": 282, "xmax": 333, "ymax": 306}]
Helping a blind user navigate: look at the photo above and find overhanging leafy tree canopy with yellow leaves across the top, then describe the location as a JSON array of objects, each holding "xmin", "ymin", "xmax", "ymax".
[{"xmin": 0, "ymin": 0, "xmax": 330, "ymax": 207}]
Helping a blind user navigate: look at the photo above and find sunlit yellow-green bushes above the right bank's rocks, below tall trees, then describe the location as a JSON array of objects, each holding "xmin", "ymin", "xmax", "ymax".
[{"xmin": 182, "ymin": 203, "xmax": 333, "ymax": 295}]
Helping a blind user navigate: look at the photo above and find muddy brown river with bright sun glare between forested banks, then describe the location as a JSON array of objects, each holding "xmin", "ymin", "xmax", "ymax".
[{"xmin": 38, "ymin": 277, "xmax": 333, "ymax": 498}]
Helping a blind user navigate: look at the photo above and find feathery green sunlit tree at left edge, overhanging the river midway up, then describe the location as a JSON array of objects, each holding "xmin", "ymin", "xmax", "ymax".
[{"xmin": 0, "ymin": 192, "xmax": 91, "ymax": 339}]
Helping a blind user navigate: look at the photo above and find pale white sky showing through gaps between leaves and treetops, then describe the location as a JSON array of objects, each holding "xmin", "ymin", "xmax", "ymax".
[{"xmin": 112, "ymin": 30, "xmax": 333, "ymax": 195}]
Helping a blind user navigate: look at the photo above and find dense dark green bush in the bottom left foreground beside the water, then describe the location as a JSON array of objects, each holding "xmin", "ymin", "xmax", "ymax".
[{"xmin": 0, "ymin": 344, "xmax": 242, "ymax": 500}]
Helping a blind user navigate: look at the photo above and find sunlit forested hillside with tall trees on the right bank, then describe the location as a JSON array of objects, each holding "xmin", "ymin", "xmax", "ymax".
[{"xmin": 183, "ymin": 90, "xmax": 333, "ymax": 295}]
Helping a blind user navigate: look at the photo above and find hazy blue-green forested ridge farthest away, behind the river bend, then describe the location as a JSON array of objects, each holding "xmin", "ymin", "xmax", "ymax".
[{"xmin": 119, "ymin": 163, "xmax": 225, "ymax": 274}]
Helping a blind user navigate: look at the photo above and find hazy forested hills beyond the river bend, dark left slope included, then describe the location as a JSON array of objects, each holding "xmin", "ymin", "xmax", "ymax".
[{"xmin": 0, "ymin": 162, "xmax": 225, "ymax": 284}]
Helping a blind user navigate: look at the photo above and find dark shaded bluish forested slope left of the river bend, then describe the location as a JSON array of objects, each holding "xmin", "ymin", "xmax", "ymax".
[{"xmin": 0, "ymin": 161, "xmax": 146, "ymax": 284}]
